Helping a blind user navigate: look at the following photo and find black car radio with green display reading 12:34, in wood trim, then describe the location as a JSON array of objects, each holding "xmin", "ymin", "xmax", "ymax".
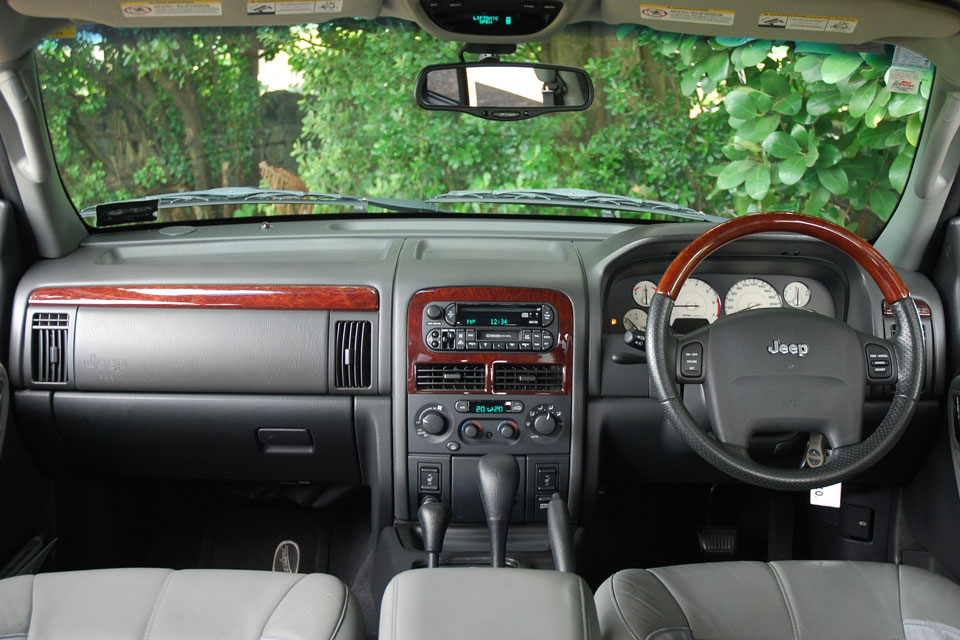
[{"xmin": 421, "ymin": 302, "xmax": 557, "ymax": 353}]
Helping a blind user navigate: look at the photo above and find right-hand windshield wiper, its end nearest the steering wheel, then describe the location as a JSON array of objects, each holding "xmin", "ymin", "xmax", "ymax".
[{"xmin": 427, "ymin": 189, "xmax": 725, "ymax": 222}]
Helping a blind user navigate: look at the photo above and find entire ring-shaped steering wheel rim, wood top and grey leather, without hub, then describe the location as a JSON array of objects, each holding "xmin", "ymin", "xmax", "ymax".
[{"xmin": 646, "ymin": 213, "xmax": 924, "ymax": 490}]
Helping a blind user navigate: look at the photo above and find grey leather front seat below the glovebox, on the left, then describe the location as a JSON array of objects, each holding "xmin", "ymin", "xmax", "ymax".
[{"xmin": 0, "ymin": 569, "xmax": 364, "ymax": 640}]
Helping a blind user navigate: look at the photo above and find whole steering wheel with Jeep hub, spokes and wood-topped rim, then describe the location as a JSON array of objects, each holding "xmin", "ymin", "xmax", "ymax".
[{"xmin": 646, "ymin": 213, "xmax": 924, "ymax": 490}]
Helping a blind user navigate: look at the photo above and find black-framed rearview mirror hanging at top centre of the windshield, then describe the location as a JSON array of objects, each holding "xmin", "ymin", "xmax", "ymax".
[{"xmin": 417, "ymin": 62, "xmax": 593, "ymax": 120}]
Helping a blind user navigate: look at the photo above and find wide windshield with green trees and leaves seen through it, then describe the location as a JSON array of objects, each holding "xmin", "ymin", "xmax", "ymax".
[{"xmin": 37, "ymin": 20, "xmax": 933, "ymax": 240}]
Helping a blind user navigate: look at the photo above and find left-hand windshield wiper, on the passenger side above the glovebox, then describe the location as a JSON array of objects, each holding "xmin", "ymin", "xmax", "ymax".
[{"xmin": 80, "ymin": 187, "xmax": 439, "ymax": 217}]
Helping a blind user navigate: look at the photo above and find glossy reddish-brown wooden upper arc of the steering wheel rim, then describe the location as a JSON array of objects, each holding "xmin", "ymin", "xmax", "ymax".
[{"xmin": 657, "ymin": 211, "xmax": 910, "ymax": 304}]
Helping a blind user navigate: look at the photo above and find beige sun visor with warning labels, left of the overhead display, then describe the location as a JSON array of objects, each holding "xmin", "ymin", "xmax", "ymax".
[{"xmin": 9, "ymin": 0, "xmax": 383, "ymax": 28}]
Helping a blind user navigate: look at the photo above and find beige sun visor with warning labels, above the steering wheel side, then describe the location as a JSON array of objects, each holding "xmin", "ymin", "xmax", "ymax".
[{"xmin": 601, "ymin": 0, "xmax": 960, "ymax": 44}]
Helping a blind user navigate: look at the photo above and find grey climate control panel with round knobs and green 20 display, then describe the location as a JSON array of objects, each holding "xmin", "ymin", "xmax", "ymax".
[{"xmin": 407, "ymin": 394, "xmax": 570, "ymax": 455}]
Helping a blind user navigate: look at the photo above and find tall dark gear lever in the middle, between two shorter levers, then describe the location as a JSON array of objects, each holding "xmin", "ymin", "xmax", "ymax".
[{"xmin": 478, "ymin": 453, "xmax": 520, "ymax": 567}]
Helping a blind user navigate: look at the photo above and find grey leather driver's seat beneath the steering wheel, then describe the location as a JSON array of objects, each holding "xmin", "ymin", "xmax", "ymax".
[{"xmin": 596, "ymin": 561, "xmax": 960, "ymax": 640}]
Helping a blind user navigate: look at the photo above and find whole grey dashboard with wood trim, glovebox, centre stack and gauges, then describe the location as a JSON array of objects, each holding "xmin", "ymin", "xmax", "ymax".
[{"xmin": 3, "ymin": 218, "xmax": 946, "ymax": 527}]
